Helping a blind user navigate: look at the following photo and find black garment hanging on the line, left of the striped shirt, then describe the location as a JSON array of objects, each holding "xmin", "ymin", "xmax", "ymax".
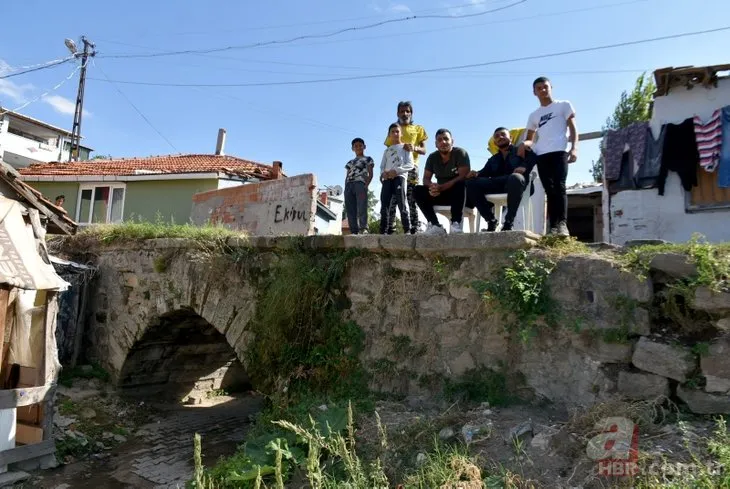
[{"xmin": 657, "ymin": 117, "xmax": 700, "ymax": 195}]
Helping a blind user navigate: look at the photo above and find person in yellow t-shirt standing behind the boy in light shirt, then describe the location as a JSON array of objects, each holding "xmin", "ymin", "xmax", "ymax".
[{"xmin": 385, "ymin": 101, "xmax": 428, "ymax": 234}]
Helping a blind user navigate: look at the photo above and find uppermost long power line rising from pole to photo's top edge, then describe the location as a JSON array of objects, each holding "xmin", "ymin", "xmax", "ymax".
[{"xmin": 99, "ymin": 0, "xmax": 527, "ymax": 58}]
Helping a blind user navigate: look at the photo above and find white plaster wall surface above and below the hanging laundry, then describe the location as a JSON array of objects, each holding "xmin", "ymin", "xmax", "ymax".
[{"xmin": 604, "ymin": 79, "xmax": 730, "ymax": 245}]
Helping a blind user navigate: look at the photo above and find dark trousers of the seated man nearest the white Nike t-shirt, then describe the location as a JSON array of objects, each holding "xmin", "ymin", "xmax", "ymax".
[{"xmin": 466, "ymin": 173, "xmax": 528, "ymax": 222}]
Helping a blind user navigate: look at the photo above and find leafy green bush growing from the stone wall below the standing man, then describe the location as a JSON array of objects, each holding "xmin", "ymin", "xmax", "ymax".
[{"xmin": 473, "ymin": 250, "xmax": 558, "ymax": 342}]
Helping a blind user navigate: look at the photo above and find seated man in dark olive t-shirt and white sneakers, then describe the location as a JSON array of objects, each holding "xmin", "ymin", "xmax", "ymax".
[{"xmin": 413, "ymin": 129, "xmax": 471, "ymax": 235}]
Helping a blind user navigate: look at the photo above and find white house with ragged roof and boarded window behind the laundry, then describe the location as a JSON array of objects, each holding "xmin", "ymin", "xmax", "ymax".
[{"xmin": 602, "ymin": 65, "xmax": 730, "ymax": 245}]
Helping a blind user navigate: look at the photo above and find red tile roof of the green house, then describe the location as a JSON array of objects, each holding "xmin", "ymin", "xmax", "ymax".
[{"xmin": 18, "ymin": 155, "xmax": 273, "ymax": 180}]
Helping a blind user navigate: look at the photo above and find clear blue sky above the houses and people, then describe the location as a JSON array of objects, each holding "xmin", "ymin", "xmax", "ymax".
[{"xmin": 0, "ymin": 0, "xmax": 730, "ymax": 193}]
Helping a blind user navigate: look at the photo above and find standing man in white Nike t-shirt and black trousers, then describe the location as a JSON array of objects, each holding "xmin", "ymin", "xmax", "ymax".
[{"xmin": 520, "ymin": 76, "xmax": 578, "ymax": 236}]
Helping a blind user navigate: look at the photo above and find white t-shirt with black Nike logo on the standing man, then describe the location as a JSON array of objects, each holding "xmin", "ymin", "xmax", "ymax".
[{"xmin": 527, "ymin": 100, "xmax": 575, "ymax": 155}]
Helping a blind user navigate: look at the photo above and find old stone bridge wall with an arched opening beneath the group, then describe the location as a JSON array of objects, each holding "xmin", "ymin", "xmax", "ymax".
[{"xmin": 58, "ymin": 232, "xmax": 730, "ymax": 413}]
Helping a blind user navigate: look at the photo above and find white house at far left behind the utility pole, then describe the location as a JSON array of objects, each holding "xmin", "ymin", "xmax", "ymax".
[{"xmin": 0, "ymin": 107, "xmax": 93, "ymax": 168}]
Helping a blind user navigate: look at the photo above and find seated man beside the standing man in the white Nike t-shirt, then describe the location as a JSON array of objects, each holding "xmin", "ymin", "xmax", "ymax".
[{"xmin": 466, "ymin": 127, "xmax": 535, "ymax": 231}]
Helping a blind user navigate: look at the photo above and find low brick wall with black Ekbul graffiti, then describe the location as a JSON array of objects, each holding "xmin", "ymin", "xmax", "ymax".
[{"xmin": 191, "ymin": 174, "xmax": 317, "ymax": 236}]
